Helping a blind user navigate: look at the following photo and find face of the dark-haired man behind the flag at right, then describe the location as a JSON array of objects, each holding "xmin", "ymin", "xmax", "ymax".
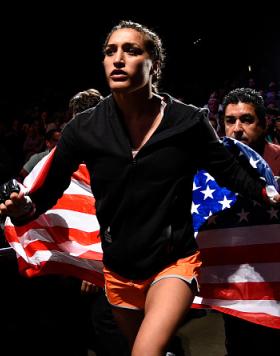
[{"xmin": 224, "ymin": 102, "xmax": 265, "ymax": 148}]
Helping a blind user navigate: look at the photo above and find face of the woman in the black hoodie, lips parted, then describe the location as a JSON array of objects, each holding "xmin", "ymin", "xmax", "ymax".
[{"xmin": 103, "ymin": 28, "xmax": 156, "ymax": 93}]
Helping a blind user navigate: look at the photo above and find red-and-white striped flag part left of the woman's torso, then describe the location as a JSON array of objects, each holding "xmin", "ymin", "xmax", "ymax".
[{"xmin": 5, "ymin": 150, "xmax": 104, "ymax": 287}]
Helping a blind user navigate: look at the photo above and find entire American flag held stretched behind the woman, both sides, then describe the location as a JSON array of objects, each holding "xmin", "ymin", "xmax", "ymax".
[{"xmin": 5, "ymin": 138, "xmax": 280, "ymax": 329}]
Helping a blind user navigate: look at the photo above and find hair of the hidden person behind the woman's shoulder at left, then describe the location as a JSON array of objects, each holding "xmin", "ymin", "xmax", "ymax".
[{"xmin": 69, "ymin": 89, "xmax": 103, "ymax": 115}]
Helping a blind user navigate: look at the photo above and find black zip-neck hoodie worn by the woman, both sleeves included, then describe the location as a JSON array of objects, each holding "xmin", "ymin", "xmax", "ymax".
[{"xmin": 25, "ymin": 94, "xmax": 264, "ymax": 279}]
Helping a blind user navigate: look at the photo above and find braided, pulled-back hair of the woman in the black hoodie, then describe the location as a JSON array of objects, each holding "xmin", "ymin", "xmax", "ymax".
[{"xmin": 103, "ymin": 21, "xmax": 165, "ymax": 89}]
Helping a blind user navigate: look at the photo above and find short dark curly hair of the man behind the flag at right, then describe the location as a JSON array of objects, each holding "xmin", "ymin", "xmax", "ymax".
[{"xmin": 222, "ymin": 88, "xmax": 266, "ymax": 127}]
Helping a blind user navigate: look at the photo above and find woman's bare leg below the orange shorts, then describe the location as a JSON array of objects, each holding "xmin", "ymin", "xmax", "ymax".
[{"xmin": 132, "ymin": 278, "xmax": 194, "ymax": 356}]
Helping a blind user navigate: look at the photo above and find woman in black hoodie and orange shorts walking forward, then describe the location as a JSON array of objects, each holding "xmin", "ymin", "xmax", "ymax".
[{"xmin": 1, "ymin": 21, "xmax": 280, "ymax": 356}]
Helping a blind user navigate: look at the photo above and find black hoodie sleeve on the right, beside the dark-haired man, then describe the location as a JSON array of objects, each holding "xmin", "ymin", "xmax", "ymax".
[{"xmin": 197, "ymin": 111, "xmax": 265, "ymax": 203}]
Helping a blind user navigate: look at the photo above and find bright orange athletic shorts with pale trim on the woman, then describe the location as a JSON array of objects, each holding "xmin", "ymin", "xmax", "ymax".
[{"xmin": 103, "ymin": 251, "xmax": 201, "ymax": 310}]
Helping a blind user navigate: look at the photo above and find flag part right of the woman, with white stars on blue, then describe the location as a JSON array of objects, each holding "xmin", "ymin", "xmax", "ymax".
[{"xmin": 192, "ymin": 138, "xmax": 280, "ymax": 328}]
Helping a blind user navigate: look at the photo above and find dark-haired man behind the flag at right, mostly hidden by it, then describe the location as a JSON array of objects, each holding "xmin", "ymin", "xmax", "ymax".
[{"xmin": 223, "ymin": 88, "xmax": 280, "ymax": 356}]
